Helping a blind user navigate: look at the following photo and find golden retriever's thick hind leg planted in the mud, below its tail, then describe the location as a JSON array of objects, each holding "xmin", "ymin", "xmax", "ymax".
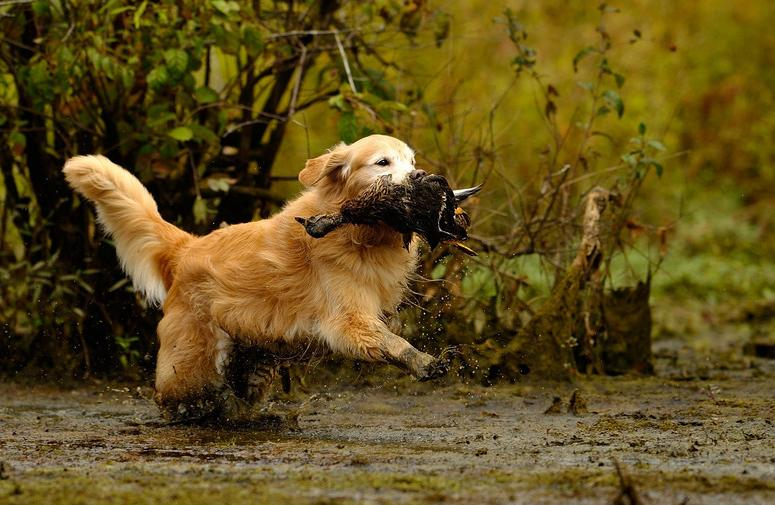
[{"xmin": 154, "ymin": 297, "xmax": 233, "ymax": 421}]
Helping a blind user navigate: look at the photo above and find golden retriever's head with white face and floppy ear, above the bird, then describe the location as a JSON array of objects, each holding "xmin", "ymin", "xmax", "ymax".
[{"xmin": 299, "ymin": 135, "xmax": 414, "ymax": 199}]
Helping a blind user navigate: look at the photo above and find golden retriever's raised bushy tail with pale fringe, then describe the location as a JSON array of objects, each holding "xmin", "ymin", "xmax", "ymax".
[{"xmin": 63, "ymin": 156, "xmax": 193, "ymax": 303}]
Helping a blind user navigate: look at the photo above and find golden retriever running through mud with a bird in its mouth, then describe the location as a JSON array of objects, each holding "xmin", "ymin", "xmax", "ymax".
[{"xmin": 64, "ymin": 135, "xmax": 443, "ymax": 417}]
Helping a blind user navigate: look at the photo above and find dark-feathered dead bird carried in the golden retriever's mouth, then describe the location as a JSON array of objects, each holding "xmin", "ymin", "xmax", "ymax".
[{"xmin": 296, "ymin": 170, "xmax": 481, "ymax": 255}]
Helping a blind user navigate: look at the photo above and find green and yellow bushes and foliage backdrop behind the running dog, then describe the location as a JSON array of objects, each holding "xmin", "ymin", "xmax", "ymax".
[{"xmin": 0, "ymin": 0, "xmax": 775, "ymax": 377}]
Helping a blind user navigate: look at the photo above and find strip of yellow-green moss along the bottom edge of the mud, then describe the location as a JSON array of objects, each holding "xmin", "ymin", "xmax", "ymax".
[{"xmin": 0, "ymin": 454, "xmax": 775, "ymax": 505}]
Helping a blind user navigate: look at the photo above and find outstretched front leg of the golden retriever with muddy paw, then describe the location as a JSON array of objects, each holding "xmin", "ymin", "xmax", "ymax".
[{"xmin": 320, "ymin": 313, "xmax": 448, "ymax": 380}]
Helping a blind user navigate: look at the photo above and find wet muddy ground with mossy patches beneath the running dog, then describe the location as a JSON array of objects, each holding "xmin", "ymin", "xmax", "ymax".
[{"xmin": 0, "ymin": 334, "xmax": 775, "ymax": 504}]
